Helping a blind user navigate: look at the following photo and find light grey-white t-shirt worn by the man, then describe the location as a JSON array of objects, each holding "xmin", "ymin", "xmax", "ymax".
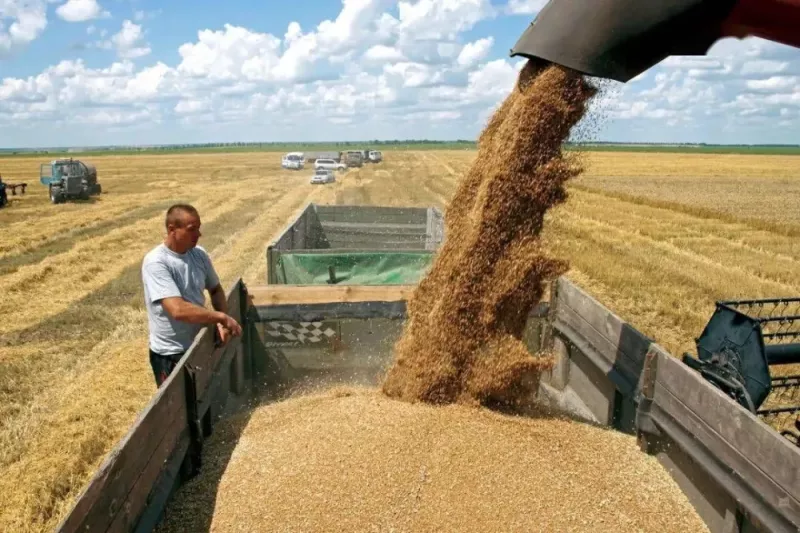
[{"xmin": 142, "ymin": 243, "xmax": 219, "ymax": 355}]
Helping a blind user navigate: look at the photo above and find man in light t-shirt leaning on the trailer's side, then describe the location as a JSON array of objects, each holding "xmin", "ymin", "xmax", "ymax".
[{"xmin": 142, "ymin": 204, "xmax": 242, "ymax": 387}]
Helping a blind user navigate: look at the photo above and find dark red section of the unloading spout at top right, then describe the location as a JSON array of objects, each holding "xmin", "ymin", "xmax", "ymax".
[{"xmin": 722, "ymin": 0, "xmax": 800, "ymax": 47}]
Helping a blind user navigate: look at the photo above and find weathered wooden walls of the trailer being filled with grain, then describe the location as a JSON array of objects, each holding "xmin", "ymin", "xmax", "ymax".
[{"xmin": 58, "ymin": 206, "xmax": 800, "ymax": 533}]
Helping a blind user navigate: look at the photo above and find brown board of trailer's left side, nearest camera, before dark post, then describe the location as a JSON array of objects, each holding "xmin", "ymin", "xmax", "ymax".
[{"xmin": 57, "ymin": 366, "xmax": 186, "ymax": 533}]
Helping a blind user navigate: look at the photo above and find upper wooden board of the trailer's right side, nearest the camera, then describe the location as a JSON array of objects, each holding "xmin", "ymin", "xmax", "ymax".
[{"xmin": 655, "ymin": 357, "xmax": 800, "ymax": 523}]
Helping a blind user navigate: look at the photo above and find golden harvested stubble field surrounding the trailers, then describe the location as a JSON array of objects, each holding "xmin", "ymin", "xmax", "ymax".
[{"xmin": 0, "ymin": 151, "xmax": 800, "ymax": 532}]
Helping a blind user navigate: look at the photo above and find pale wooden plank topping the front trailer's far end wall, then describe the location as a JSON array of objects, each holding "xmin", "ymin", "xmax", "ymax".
[{"xmin": 247, "ymin": 285, "xmax": 416, "ymax": 307}]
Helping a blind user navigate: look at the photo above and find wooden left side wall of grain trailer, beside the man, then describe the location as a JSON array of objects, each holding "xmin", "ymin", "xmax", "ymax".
[{"xmin": 57, "ymin": 280, "xmax": 250, "ymax": 533}]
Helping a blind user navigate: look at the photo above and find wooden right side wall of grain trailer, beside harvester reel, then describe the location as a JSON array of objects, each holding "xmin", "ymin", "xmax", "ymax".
[{"xmin": 542, "ymin": 278, "xmax": 800, "ymax": 533}]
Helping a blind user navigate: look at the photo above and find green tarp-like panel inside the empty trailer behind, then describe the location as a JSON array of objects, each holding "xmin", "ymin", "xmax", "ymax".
[{"xmin": 277, "ymin": 252, "xmax": 433, "ymax": 285}]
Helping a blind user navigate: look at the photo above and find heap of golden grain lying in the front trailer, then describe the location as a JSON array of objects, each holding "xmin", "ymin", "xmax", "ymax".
[{"xmin": 157, "ymin": 388, "xmax": 708, "ymax": 533}]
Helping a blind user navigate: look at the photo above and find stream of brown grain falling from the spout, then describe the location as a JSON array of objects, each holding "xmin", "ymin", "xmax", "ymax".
[{"xmin": 383, "ymin": 62, "xmax": 597, "ymax": 404}]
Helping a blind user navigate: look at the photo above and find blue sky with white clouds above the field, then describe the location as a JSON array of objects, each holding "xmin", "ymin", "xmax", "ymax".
[{"xmin": 0, "ymin": 0, "xmax": 800, "ymax": 148}]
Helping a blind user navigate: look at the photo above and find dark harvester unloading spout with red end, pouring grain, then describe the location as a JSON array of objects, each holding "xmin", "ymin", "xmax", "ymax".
[{"xmin": 511, "ymin": 0, "xmax": 800, "ymax": 82}]
